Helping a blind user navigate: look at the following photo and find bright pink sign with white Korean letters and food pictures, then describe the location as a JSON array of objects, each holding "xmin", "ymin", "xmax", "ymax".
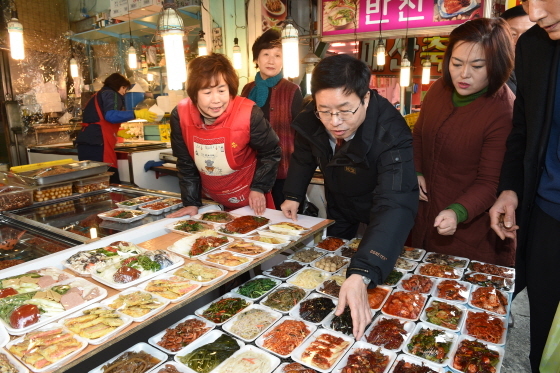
[{"xmin": 322, "ymin": 0, "xmax": 483, "ymax": 35}]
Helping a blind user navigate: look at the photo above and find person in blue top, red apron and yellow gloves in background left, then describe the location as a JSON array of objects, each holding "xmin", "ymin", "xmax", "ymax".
[{"xmin": 76, "ymin": 73, "xmax": 156, "ymax": 183}]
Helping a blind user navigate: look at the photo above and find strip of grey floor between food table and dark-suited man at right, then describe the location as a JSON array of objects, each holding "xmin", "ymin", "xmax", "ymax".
[{"xmin": 500, "ymin": 289, "xmax": 531, "ymax": 373}]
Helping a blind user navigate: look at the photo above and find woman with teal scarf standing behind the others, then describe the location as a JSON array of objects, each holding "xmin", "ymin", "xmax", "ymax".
[{"xmin": 241, "ymin": 29, "xmax": 303, "ymax": 209}]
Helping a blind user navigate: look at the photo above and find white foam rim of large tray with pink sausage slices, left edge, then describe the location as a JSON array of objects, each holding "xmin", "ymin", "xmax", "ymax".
[{"xmin": 0, "ymin": 277, "xmax": 107, "ymax": 335}]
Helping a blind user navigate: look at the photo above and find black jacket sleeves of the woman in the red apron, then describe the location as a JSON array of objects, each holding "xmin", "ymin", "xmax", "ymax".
[{"xmin": 167, "ymin": 105, "xmax": 282, "ymax": 206}]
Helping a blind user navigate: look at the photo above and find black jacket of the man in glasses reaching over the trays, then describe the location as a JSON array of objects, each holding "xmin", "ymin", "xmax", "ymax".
[{"xmin": 284, "ymin": 90, "xmax": 418, "ymax": 287}]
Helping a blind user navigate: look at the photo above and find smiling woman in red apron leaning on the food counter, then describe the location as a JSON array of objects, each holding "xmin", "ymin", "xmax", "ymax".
[{"xmin": 168, "ymin": 53, "xmax": 282, "ymax": 217}]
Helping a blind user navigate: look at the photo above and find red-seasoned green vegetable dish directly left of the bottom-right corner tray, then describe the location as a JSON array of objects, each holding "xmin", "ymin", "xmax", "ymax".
[{"xmin": 407, "ymin": 329, "xmax": 451, "ymax": 364}]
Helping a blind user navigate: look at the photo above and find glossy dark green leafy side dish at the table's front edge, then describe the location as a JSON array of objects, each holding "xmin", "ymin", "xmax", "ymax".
[{"xmin": 178, "ymin": 334, "xmax": 239, "ymax": 373}]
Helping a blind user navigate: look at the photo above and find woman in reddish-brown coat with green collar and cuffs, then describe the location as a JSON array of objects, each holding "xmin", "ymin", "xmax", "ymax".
[{"xmin": 411, "ymin": 18, "xmax": 515, "ymax": 265}]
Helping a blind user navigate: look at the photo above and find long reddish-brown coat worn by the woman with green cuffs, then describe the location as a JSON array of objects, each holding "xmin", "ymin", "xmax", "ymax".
[{"xmin": 411, "ymin": 79, "xmax": 515, "ymax": 265}]
